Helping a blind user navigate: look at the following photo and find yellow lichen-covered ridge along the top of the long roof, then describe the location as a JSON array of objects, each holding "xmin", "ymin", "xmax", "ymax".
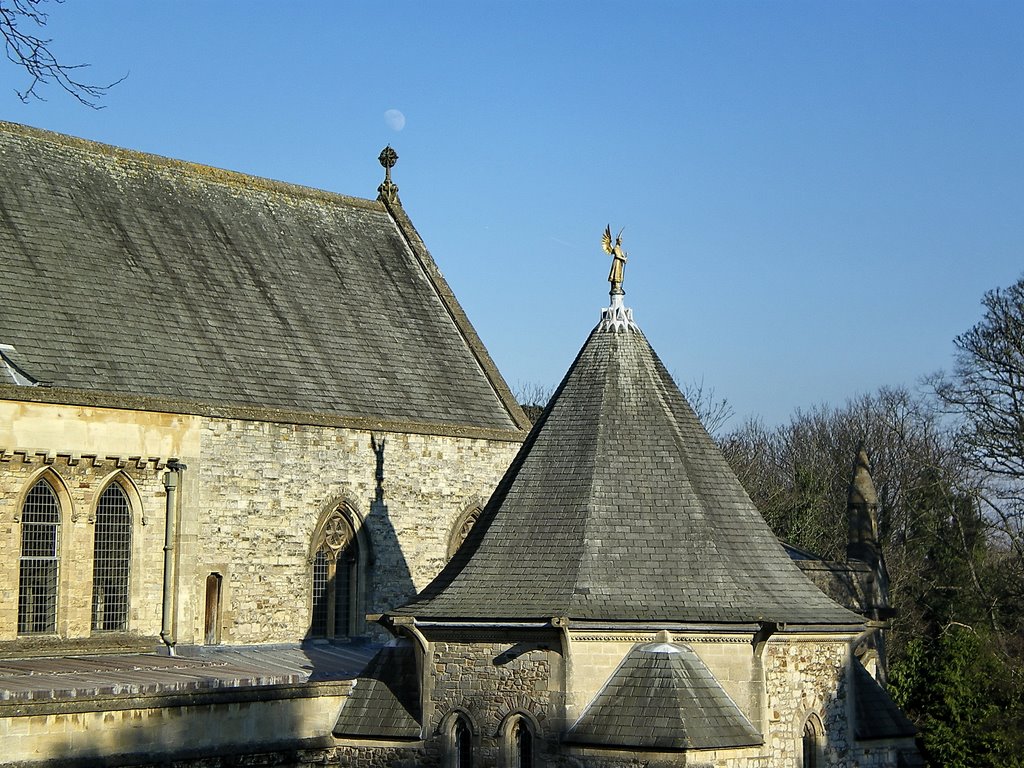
[{"xmin": 0, "ymin": 120, "xmax": 383, "ymax": 210}]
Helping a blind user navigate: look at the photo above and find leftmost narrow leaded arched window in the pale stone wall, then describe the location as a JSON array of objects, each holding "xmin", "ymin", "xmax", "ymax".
[{"xmin": 17, "ymin": 479, "xmax": 60, "ymax": 635}]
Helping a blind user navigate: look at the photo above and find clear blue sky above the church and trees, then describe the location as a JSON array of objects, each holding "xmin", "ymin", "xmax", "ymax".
[{"xmin": 9, "ymin": 0, "xmax": 1024, "ymax": 426}]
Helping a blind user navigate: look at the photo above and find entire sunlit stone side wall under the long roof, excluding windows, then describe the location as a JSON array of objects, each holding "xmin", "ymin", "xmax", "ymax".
[{"xmin": 0, "ymin": 400, "xmax": 519, "ymax": 652}]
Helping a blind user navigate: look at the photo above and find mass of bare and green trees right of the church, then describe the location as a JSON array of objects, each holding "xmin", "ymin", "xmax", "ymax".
[{"xmin": 720, "ymin": 279, "xmax": 1024, "ymax": 768}]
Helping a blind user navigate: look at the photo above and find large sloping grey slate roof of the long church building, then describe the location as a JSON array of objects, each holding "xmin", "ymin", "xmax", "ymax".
[{"xmin": 0, "ymin": 123, "xmax": 526, "ymax": 430}]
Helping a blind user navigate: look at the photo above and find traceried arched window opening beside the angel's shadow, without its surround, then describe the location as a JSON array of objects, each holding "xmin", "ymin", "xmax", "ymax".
[{"xmin": 309, "ymin": 507, "xmax": 359, "ymax": 639}]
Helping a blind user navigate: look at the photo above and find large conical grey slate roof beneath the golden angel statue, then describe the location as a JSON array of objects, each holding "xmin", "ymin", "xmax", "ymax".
[{"xmin": 393, "ymin": 303, "xmax": 863, "ymax": 627}]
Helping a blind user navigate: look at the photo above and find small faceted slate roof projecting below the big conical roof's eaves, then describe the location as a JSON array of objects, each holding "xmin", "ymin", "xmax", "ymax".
[{"xmin": 566, "ymin": 643, "xmax": 762, "ymax": 750}]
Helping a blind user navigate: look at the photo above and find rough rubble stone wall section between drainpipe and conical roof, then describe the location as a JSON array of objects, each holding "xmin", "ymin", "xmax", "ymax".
[{"xmin": 188, "ymin": 420, "xmax": 518, "ymax": 643}]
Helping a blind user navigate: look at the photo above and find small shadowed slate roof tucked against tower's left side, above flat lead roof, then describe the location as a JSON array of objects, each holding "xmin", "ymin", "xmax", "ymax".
[{"xmin": 334, "ymin": 641, "xmax": 421, "ymax": 739}]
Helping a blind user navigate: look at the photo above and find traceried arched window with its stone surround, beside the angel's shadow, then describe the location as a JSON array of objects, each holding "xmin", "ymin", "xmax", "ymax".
[{"xmin": 307, "ymin": 498, "xmax": 372, "ymax": 640}]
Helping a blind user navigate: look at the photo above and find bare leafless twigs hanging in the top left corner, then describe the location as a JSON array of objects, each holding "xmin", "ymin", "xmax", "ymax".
[{"xmin": 0, "ymin": 0, "xmax": 127, "ymax": 110}]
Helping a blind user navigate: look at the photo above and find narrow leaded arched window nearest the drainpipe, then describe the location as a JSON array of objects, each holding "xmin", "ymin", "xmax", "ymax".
[{"xmin": 92, "ymin": 482, "xmax": 131, "ymax": 632}]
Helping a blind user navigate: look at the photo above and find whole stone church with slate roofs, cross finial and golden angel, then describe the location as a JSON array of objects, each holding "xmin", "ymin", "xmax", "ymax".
[{"xmin": 0, "ymin": 123, "xmax": 920, "ymax": 768}]
